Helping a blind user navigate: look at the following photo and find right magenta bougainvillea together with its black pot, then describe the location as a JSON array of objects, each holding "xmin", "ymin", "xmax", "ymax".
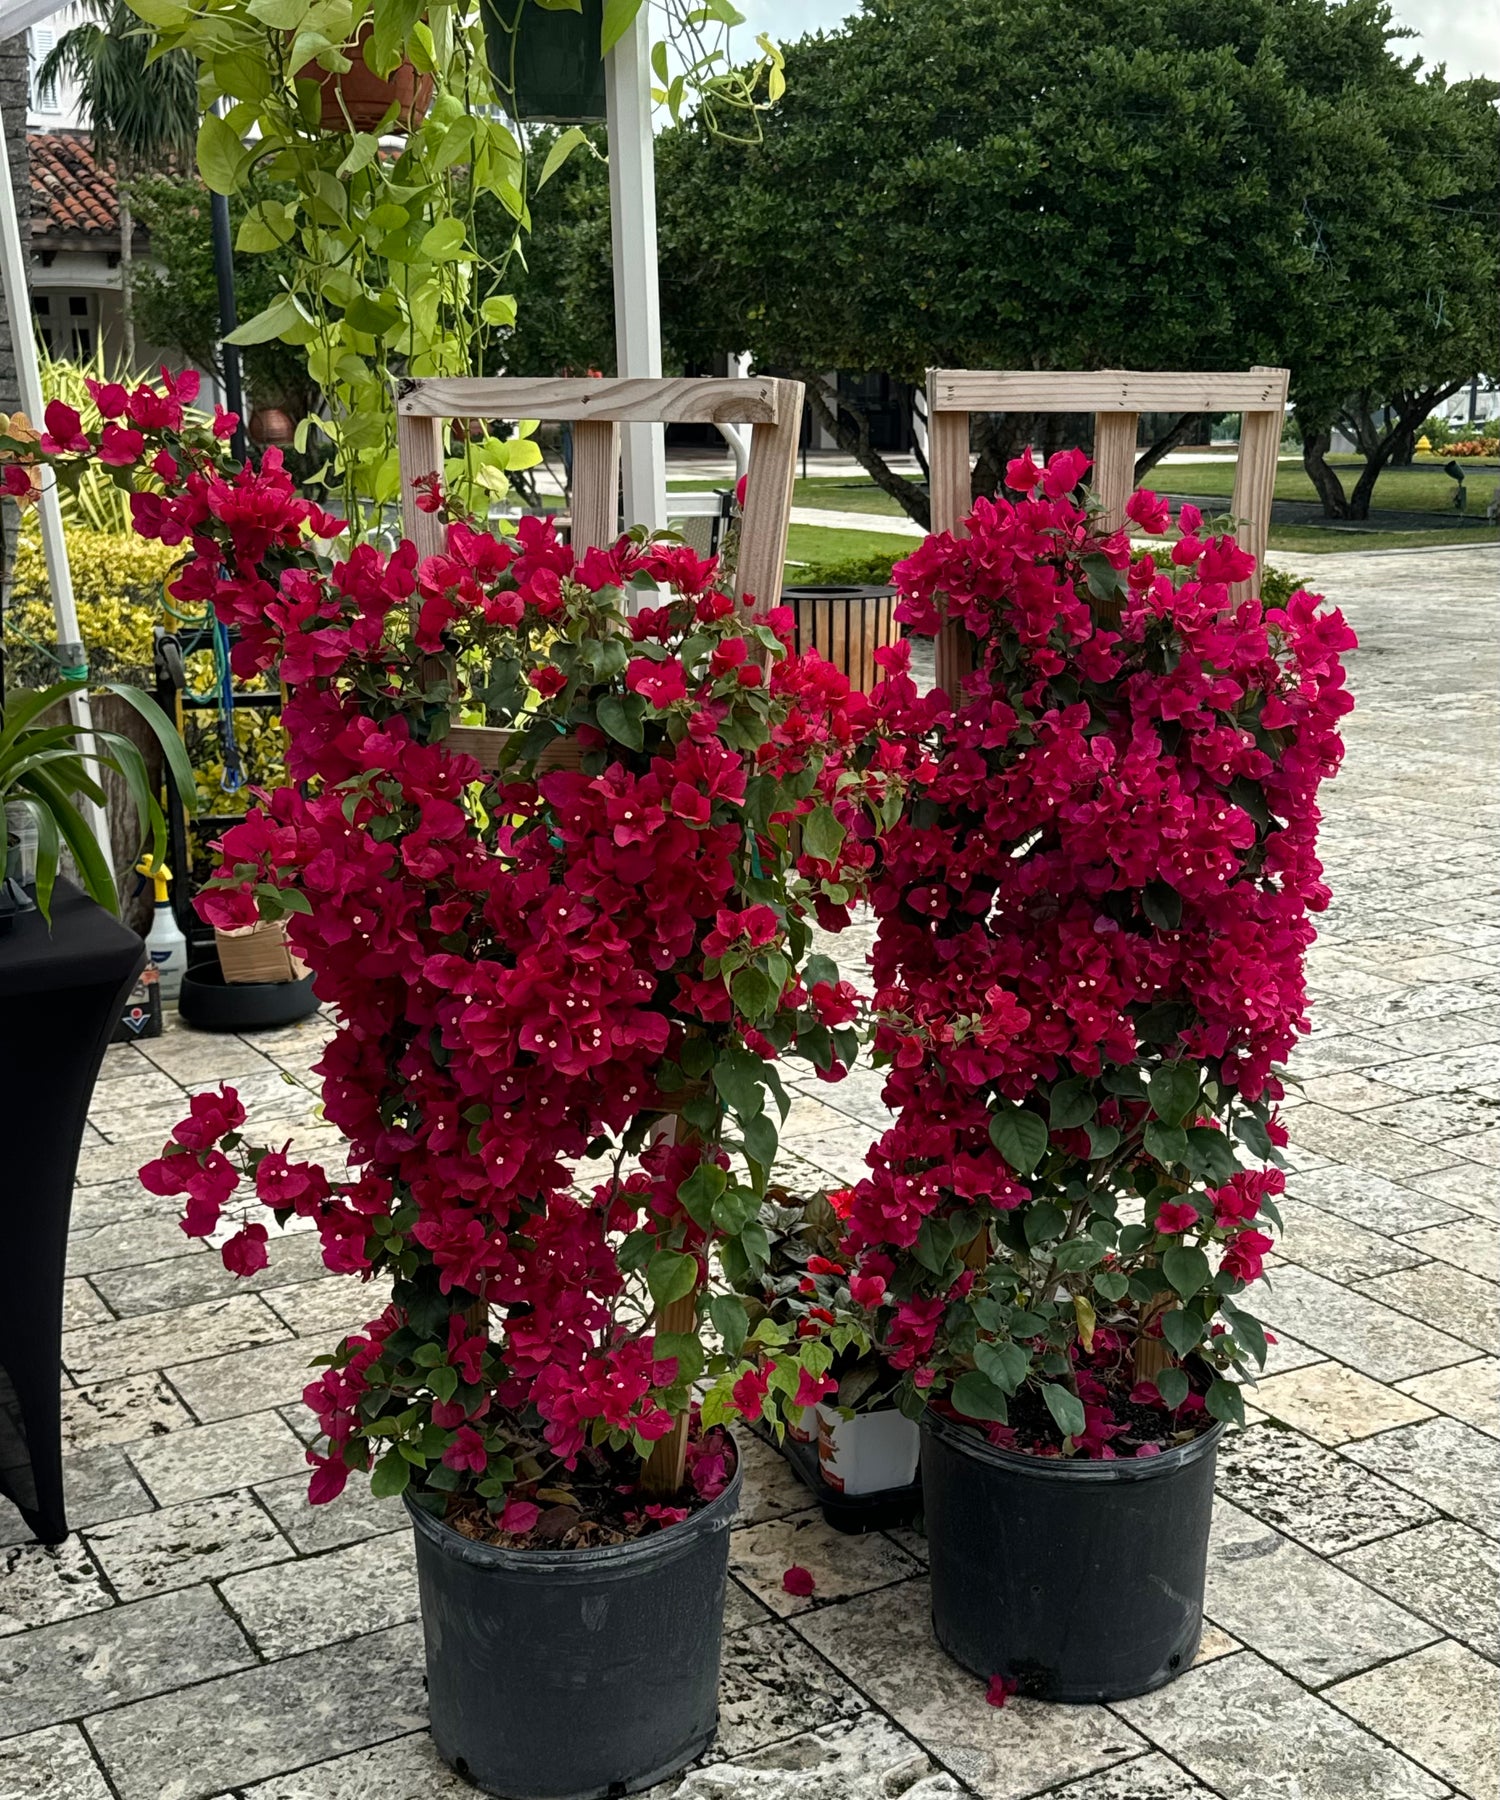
[{"xmin": 795, "ymin": 452, "xmax": 1354, "ymax": 1701}]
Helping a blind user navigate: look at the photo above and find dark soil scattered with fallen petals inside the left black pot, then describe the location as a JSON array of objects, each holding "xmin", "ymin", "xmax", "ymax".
[{"xmin": 443, "ymin": 1426, "xmax": 738, "ymax": 1550}]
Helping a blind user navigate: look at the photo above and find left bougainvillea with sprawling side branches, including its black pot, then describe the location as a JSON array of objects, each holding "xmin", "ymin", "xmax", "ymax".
[{"xmin": 46, "ymin": 372, "xmax": 872, "ymax": 1796}]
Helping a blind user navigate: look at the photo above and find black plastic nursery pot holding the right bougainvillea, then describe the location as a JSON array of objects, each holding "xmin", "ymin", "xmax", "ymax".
[{"xmin": 922, "ymin": 1411, "xmax": 1223, "ymax": 1701}]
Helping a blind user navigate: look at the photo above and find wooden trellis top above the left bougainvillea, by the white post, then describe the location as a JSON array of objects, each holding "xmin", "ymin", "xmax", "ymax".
[{"xmin": 396, "ymin": 376, "xmax": 803, "ymax": 769}]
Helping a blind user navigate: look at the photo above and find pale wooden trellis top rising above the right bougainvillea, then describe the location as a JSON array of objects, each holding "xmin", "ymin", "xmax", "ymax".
[{"xmin": 927, "ymin": 367, "xmax": 1288, "ymax": 698}]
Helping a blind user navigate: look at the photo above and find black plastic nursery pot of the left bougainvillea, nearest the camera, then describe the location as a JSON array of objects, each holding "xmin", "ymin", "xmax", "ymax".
[{"xmin": 407, "ymin": 1465, "xmax": 740, "ymax": 1800}]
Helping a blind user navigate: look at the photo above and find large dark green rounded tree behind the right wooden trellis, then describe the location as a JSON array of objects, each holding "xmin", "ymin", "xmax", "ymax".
[{"xmin": 659, "ymin": 0, "xmax": 1484, "ymax": 522}]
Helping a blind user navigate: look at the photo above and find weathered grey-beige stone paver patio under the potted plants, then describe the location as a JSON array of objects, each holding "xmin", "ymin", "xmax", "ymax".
[{"xmin": 0, "ymin": 551, "xmax": 1500, "ymax": 1800}]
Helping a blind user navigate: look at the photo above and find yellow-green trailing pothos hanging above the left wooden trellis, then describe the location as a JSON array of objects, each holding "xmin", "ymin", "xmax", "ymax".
[{"xmin": 130, "ymin": 0, "xmax": 782, "ymax": 520}]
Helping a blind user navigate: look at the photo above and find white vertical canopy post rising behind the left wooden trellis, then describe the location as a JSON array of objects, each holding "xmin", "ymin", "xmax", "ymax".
[{"xmin": 605, "ymin": 0, "xmax": 666, "ymax": 531}]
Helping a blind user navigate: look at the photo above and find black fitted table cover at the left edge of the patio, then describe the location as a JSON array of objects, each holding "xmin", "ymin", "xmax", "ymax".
[{"xmin": 0, "ymin": 880, "xmax": 146, "ymax": 1544}]
